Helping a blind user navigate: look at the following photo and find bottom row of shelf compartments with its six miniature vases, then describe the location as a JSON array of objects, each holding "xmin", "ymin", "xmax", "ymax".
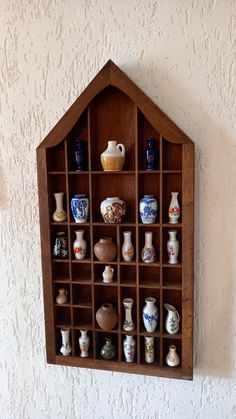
[{"xmin": 57, "ymin": 328, "xmax": 181, "ymax": 367}]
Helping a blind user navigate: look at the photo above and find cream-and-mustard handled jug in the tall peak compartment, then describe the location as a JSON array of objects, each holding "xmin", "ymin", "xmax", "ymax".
[{"xmin": 101, "ymin": 141, "xmax": 125, "ymax": 171}]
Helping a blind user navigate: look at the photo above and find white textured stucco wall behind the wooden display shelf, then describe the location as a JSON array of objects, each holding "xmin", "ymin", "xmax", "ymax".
[{"xmin": 0, "ymin": 0, "xmax": 236, "ymax": 419}]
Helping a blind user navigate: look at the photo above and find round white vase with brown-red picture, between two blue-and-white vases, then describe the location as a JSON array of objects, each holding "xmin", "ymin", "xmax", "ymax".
[{"xmin": 100, "ymin": 196, "xmax": 126, "ymax": 224}]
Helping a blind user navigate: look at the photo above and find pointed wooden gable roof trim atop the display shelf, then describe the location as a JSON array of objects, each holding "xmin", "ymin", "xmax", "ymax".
[{"xmin": 38, "ymin": 60, "xmax": 192, "ymax": 148}]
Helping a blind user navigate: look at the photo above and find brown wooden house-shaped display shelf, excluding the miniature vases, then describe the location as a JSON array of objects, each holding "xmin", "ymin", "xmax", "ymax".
[{"xmin": 37, "ymin": 61, "xmax": 194, "ymax": 379}]
